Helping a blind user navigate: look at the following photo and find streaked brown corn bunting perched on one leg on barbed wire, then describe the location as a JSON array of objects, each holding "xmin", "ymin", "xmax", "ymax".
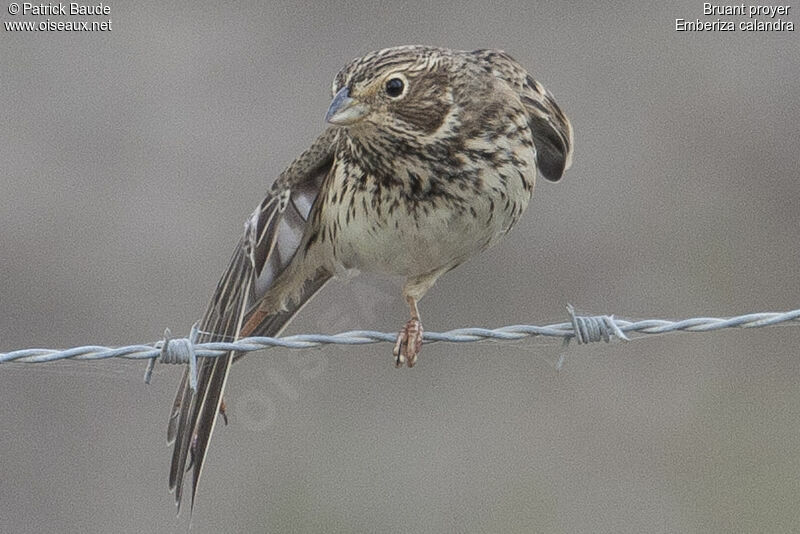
[{"xmin": 167, "ymin": 45, "xmax": 573, "ymax": 512}]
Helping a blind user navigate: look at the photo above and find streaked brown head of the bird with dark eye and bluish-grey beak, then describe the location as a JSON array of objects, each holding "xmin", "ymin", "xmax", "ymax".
[{"xmin": 325, "ymin": 46, "xmax": 453, "ymax": 137}]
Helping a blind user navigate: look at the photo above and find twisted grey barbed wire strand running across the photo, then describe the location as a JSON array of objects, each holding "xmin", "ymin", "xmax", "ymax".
[{"xmin": 0, "ymin": 305, "xmax": 800, "ymax": 387}]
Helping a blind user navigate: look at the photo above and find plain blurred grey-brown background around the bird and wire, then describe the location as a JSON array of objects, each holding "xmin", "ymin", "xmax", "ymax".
[{"xmin": 0, "ymin": 1, "xmax": 800, "ymax": 533}]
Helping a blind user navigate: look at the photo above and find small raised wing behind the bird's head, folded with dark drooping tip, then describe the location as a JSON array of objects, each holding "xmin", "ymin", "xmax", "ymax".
[{"xmin": 472, "ymin": 50, "xmax": 573, "ymax": 182}]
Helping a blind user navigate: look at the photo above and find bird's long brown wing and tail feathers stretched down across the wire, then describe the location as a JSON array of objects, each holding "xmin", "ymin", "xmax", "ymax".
[{"xmin": 167, "ymin": 129, "xmax": 336, "ymax": 510}]
